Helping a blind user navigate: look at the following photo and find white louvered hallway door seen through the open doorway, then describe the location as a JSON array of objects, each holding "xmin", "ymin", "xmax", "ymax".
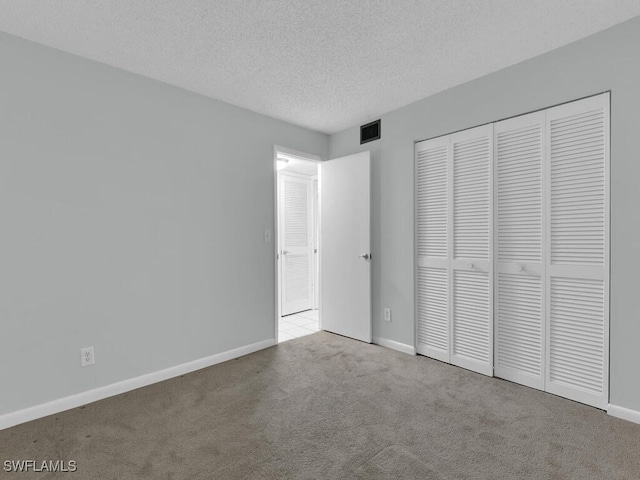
[{"xmin": 279, "ymin": 172, "xmax": 315, "ymax": 315}]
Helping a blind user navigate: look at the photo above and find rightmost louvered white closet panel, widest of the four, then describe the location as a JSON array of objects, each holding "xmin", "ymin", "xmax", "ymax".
[{"xmin": 546, "ymin": 93, "xmax": 610, "ymax": 408}]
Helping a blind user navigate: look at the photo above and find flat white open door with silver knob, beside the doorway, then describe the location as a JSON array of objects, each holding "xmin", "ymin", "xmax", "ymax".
[{"xmin": 319, "ymin": 151, "xmax": 372, "ymax": 343}]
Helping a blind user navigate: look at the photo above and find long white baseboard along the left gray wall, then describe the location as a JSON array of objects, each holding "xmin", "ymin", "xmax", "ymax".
[{"xmin": 0, "ymin": 338, "xmax": 276, "ymax": 430}]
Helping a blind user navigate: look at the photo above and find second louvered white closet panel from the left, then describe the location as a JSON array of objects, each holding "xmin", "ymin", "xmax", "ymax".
[{"xmin": 448, "ymin": 124, "xmax": 493, "ymax": 375}]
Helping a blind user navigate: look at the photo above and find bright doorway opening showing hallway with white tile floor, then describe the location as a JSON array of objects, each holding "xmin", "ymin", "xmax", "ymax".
[{"xmin": 275, "ymin": 147, "xmax": 321, "ymax": 343}]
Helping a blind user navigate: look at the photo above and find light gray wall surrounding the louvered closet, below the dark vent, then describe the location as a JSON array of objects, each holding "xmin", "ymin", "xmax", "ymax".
[{"xmin": 330, "ymin": 17, "xmax": 640, "ymax": 411}]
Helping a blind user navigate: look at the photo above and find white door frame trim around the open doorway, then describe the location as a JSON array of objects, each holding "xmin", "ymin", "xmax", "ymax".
[{"xmin": 273, "ymin": 145, "xmax": 322, "ymax": 344}]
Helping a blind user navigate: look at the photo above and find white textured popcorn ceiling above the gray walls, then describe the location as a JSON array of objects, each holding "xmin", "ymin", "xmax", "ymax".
[{"xmin": 0, "ymin": 0, "xmax": 640, "ymax": 133}]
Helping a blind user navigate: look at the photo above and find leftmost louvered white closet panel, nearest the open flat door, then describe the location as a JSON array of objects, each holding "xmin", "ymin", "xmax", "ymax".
[{"xmin": 415, "ymin": 135, "xmax": 450, "ymax": 362}]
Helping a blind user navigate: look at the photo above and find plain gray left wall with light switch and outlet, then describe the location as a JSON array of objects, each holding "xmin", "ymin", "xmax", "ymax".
[{"xmin": 0, "ymin": 34, "xmax": 329, "ymax": 415}]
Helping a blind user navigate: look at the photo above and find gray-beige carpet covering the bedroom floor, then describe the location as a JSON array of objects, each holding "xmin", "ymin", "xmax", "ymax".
[{"xmin": 0, "ymin": 332, "xmax": 640, "ymax": 480}]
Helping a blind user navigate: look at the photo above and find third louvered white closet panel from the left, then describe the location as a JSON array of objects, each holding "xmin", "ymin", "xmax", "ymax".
[{"xmin": 494, "ymin": 111, "xmax": 545, "ymax": 390}]
